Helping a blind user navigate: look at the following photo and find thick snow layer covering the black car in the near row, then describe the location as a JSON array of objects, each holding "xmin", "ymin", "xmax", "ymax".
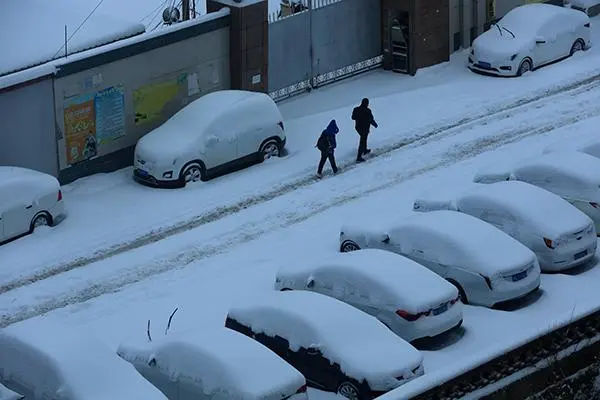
[{"xmin": 229, "ymin": 290, "xmax": 423, "ymax": 386}]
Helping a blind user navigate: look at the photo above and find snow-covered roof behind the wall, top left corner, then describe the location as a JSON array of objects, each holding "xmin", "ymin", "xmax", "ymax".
[{"xmin": 0, "ymin": 0, "xmax": 145, "ymax": 76}]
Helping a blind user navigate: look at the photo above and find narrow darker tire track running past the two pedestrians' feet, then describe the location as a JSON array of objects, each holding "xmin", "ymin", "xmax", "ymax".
[{"xmin": 0, "ymin": 74, "xmax": 600, "ymax": 295}]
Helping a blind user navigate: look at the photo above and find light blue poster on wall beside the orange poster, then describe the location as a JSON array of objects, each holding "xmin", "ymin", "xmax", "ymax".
[{"xmin": 94, "ymin": 85, "xmax": 125, "ymax": 145}]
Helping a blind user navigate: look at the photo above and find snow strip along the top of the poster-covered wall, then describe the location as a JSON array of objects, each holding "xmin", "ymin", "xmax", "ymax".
[{"xmin": 0, "ymin": 8, "xmax": 229, "ymax": 89}]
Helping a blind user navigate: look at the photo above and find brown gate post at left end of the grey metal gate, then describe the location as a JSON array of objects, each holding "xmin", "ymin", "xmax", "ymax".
[{"xmin": 206, "ymin": 0, "xmax": 269, "ymax": 93}]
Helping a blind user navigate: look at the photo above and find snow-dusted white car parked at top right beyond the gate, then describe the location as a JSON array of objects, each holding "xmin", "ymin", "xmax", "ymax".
[{"xmin": 468, "ymin": 3, "xmax": 591, "ymax": 76}]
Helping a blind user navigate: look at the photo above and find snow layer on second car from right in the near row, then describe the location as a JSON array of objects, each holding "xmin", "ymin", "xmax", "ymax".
[{"xmin": 464, "ymin": 181, "xmax": 591, "ymax": 239}]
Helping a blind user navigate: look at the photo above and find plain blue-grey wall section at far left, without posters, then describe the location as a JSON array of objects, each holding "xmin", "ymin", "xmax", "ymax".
[{"xmin": 0, "ymin": 77, "xmax": 58, "ymax": 176}]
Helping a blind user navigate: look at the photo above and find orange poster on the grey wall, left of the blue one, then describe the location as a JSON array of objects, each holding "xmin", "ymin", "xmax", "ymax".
[{"xmin": 64, "ymin": 95, "xmax": 97, "ymax": 165}]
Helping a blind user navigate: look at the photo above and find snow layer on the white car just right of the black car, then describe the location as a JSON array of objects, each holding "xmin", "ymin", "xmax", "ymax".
[{"xmin": 277, "ymin": 249, "xmax": 458, "ymax": 313}]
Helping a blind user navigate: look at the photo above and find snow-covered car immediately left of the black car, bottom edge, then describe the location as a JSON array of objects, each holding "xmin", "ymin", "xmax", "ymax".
[{"xmin": 117, "ymin": 327, "xmax": 308, "ymax": 400}]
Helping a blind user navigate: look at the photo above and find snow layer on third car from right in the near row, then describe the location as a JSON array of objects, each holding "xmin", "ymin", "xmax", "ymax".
[{"xmin": 390, "ymin": 210, "xmax": 535, "ymax": 276}]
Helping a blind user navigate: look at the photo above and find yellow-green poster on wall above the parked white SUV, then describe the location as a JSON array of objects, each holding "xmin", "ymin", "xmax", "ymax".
[{"xmin": 133, "ymin": 73, "xmax": 189, "ymax": 125}]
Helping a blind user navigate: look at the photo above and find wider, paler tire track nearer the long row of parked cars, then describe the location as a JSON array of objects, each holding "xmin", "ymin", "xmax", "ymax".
[{"xmin": 0, "ymin": 88, "xmax": 600, "ymax": 328}]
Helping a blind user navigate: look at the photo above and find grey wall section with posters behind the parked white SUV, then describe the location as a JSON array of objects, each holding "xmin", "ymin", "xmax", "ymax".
[{"xmin": 54, "ymin": 15, "xmax": 230, "ymax": 182}]
